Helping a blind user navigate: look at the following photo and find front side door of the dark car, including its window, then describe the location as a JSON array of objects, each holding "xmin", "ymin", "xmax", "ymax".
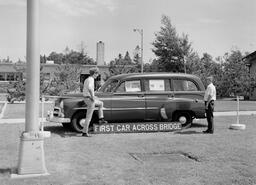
[{"xmin": 111, "ymin": 79, "xmax": 145, "ymax": 122}]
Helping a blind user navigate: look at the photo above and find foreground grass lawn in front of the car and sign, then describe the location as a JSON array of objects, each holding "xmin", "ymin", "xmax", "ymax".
[{"xmin": 0, "ymin": 116, "xmax": 256, "ymax": 185}]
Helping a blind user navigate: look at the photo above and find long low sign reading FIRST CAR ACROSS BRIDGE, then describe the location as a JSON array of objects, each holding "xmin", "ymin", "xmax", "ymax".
[{"xmin": 93, "ymin": 122, "xmax": 182, "ymax": 134}]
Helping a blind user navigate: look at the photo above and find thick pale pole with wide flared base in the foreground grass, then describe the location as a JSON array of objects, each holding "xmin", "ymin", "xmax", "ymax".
[{"xmin": 11, "ymin": 0, "xmax": 48, "ymax": 178}]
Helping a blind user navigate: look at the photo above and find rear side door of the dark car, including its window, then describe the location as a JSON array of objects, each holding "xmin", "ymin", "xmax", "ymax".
[{"xmin": 144, "ymin": 78, "xmax": 173, "ymax": 120}]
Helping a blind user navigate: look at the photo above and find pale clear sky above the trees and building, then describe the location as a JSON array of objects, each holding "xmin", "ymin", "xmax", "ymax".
[{"xmin": 0, "ymin": 0, "xmax": 256, "ymax": 63}]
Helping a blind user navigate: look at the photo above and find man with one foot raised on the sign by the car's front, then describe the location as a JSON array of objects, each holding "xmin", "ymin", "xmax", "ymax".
[{"xmin": 82, "ymin": 68, "xmax": 107, "ymax": 137}]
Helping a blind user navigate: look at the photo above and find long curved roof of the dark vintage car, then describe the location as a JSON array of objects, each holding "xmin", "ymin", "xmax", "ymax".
[{"xmin": 111, "ymin": 72, "xmax": 201, "ymax": 80}]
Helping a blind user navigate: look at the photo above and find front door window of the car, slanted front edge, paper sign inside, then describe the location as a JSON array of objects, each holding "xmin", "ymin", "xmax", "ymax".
[{"xmin": 116, "ymin": 80, "xmax": 141, "ymax": 92}]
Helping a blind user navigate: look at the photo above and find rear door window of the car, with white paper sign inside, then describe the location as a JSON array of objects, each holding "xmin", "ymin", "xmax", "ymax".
[{"xmin": 144, "ymin": 79, "xmax": 171, "ymax": 92}]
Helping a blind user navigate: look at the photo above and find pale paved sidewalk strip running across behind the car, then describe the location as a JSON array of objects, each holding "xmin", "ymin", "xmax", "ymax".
[{"xmin": 0, "ymin": 111, "xmax": 256, "ymax": 124}]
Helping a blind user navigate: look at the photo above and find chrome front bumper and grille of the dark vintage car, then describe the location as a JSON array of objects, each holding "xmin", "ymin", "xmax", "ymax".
[{"xmin": 46, "ymin": 107, "xmax": 71, "ymax": 123}]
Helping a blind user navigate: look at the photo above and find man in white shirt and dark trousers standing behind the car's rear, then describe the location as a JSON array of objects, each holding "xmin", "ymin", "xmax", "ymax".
[{"xmin": 203, "ymin": 76, "xmax": 216, "ymax": 134}]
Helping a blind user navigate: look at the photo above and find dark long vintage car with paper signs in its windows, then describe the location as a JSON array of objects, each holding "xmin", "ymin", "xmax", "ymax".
[{"xmin": 48, "ymin": 73, "xmax": 205, "ymax": 132}]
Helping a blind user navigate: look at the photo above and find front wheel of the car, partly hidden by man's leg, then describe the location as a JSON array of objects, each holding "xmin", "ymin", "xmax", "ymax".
[{"xmin": 71, "ymin": 111, "xmax": 95, "ymax": 132}]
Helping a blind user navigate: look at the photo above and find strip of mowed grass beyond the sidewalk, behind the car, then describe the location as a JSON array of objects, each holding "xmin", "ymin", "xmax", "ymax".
[{"xmin": 0, "ymin": 100, "xmax": 256, "ymax": 119}]
